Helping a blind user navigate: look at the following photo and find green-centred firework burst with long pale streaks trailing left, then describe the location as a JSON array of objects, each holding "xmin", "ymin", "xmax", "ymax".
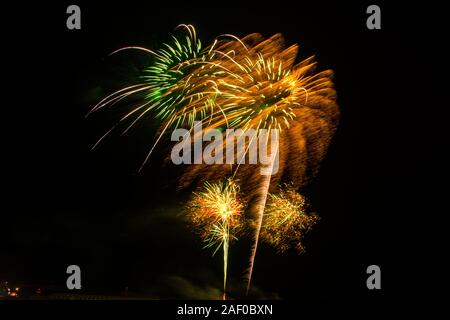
[{"xmin": 88, "ymin": 25, "xmax": 237, "ymax": 171}]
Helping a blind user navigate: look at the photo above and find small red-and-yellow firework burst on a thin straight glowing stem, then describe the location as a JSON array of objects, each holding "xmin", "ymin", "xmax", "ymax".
[{"xmin": 186, "ymin": 180, "xmax": 244, "ymax": 299}]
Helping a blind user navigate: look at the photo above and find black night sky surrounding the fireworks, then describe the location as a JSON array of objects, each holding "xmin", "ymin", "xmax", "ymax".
[{"xmin": 0, "ymin": 1, "xmax": 449, "ymax": 299}]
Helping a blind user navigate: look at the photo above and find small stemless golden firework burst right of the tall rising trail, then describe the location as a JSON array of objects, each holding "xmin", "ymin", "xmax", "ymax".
[{"xmin": 261, "ymin": 186, "xmax": 319, "ymax": 253}]
